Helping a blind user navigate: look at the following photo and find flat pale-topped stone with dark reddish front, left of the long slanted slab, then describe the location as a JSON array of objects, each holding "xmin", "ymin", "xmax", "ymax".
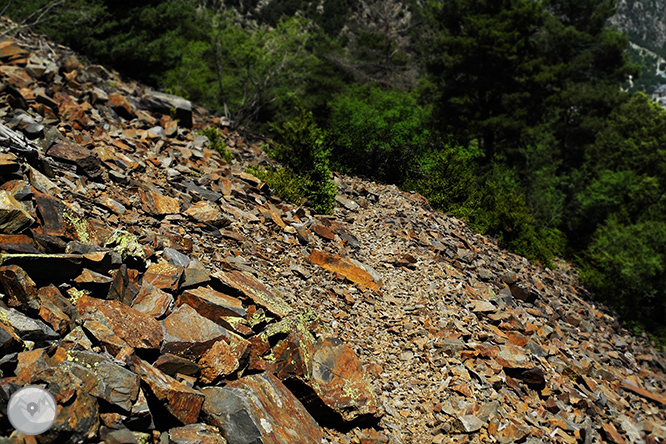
[{"xmin": 177, "ymin": 286, "xmax": 247, "ymax": 323}]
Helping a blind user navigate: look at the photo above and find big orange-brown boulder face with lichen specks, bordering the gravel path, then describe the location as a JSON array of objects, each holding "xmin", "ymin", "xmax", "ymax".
[{"xmin": 309, "ymin": 338, "xmax": 380, "ymax": 421}]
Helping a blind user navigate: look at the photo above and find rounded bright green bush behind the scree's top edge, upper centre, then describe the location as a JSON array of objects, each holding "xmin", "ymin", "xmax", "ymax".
[{"xmin": 330, "ymin": 84, "xmax": 430, "ymax": 184}]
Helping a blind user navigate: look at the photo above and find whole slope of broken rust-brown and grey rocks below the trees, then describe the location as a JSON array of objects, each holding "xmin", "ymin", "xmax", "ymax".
[{"xmin": 0, "ymin": 15, "xmax": 666, "ymax": 444}]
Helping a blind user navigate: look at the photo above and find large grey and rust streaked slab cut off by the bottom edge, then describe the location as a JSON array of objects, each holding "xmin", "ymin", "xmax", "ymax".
[{"xmin": 202, "ymin": 373, "xmax": 324, "ymax": 444}]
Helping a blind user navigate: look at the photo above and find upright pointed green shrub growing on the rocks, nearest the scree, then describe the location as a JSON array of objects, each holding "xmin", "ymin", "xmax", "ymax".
[{"xmin": 266, "ymin": 105, "xmax": 337, "ymax": 214}]
